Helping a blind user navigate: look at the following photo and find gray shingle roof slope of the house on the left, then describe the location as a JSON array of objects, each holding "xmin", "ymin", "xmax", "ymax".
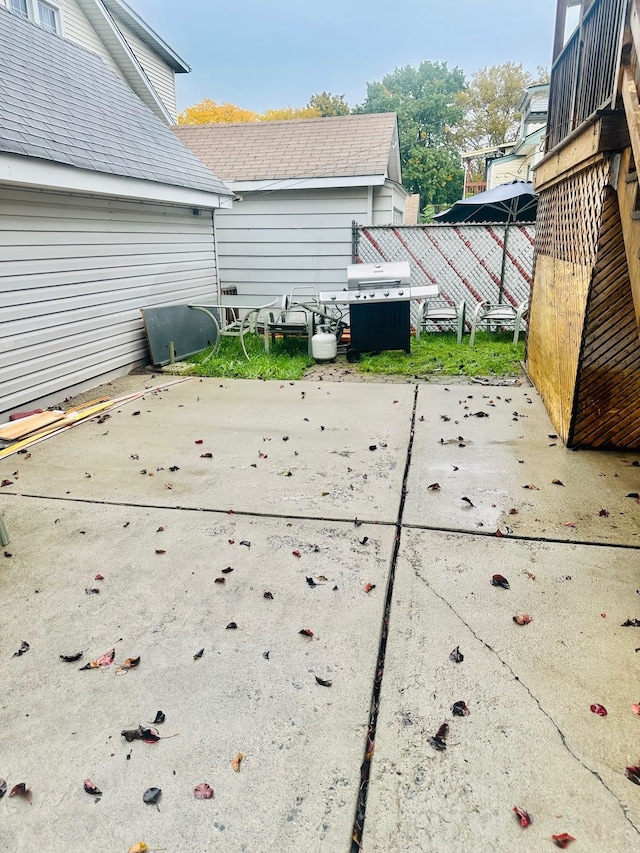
[{"xmin": 0, "ymin": 6, "xmax": 231, "ymax": 195}]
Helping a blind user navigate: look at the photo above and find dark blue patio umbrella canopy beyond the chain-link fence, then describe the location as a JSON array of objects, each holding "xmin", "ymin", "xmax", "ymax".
[{"xmin": 434, "ymin": 181, "xmax": 538, "ymax": 223}]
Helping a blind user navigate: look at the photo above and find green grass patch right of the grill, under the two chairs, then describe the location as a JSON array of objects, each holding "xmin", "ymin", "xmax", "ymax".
[{"xmin": 360, "ymin": 332, "xmax": 524, "ymax": 376}]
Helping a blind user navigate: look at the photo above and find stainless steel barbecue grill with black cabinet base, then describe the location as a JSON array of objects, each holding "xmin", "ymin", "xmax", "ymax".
[{"xmin": 319, "ymin": 261, "xmax": 438, "ymax": 361}]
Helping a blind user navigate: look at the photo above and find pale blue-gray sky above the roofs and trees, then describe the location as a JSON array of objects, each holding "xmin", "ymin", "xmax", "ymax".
[{"xmin": 128, "ymin": 0, "xmax": 556, "ymax": 112}]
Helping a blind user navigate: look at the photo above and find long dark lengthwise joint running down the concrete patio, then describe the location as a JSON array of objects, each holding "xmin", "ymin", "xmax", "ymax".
[{"xmin": 351, "ymin": 385, "xmax": 419, "ymax": 853}]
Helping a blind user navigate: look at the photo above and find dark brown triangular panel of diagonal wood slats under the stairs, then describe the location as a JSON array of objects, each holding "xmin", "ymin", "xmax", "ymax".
[{"xmin": 569, "ymin": 189, "xmax": 640, "ymax": 448}]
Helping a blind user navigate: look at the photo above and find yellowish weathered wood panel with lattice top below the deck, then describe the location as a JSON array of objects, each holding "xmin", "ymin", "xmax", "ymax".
[{"xmin": 527, "ymin": 159, "xmax": 609, "ymax": 443}]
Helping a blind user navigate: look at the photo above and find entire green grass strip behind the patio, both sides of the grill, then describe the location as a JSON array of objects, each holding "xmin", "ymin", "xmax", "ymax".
[{"xmin": 186, "ymin": 332, "xmax": 524, "ymax": 380}]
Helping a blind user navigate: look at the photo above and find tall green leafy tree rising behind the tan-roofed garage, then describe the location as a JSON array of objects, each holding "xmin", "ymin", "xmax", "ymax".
[{"xmin": 354, "ymin": 61, "xmax": 465, "ymax": 206}]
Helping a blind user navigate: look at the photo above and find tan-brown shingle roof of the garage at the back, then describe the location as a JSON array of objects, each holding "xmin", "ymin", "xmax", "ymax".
[{"xmin": 174, "ymin": 113, "xmax": 396, "ymax": 181}]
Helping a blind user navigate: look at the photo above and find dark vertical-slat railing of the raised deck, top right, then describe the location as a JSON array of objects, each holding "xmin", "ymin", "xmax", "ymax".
[{"xmin": 546, "ymin": 0, "xmax": 629, "ymax": 151}]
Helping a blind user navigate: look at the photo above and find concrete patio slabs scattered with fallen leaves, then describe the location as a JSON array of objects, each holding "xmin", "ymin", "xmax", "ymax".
[{"xmin": 0, "ymin": 376, "xmax": 640, "ymax": 853}]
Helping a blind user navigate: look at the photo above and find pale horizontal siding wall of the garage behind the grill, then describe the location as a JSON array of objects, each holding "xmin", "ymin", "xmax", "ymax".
[{"xmin": 216, "ymin": 187, "xmax": 367, "ymax": 296}]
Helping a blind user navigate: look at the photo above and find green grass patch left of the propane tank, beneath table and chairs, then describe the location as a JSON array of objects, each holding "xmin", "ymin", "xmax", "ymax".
[{"xmin": 187, "ymin": 335, "xmax": 313, "ymax": 380}]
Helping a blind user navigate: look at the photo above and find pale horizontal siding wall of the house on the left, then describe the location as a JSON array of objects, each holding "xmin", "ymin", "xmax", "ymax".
[{"xmin": 0, "ymin": 187, "xmax": 217, "ymax": 413}]
